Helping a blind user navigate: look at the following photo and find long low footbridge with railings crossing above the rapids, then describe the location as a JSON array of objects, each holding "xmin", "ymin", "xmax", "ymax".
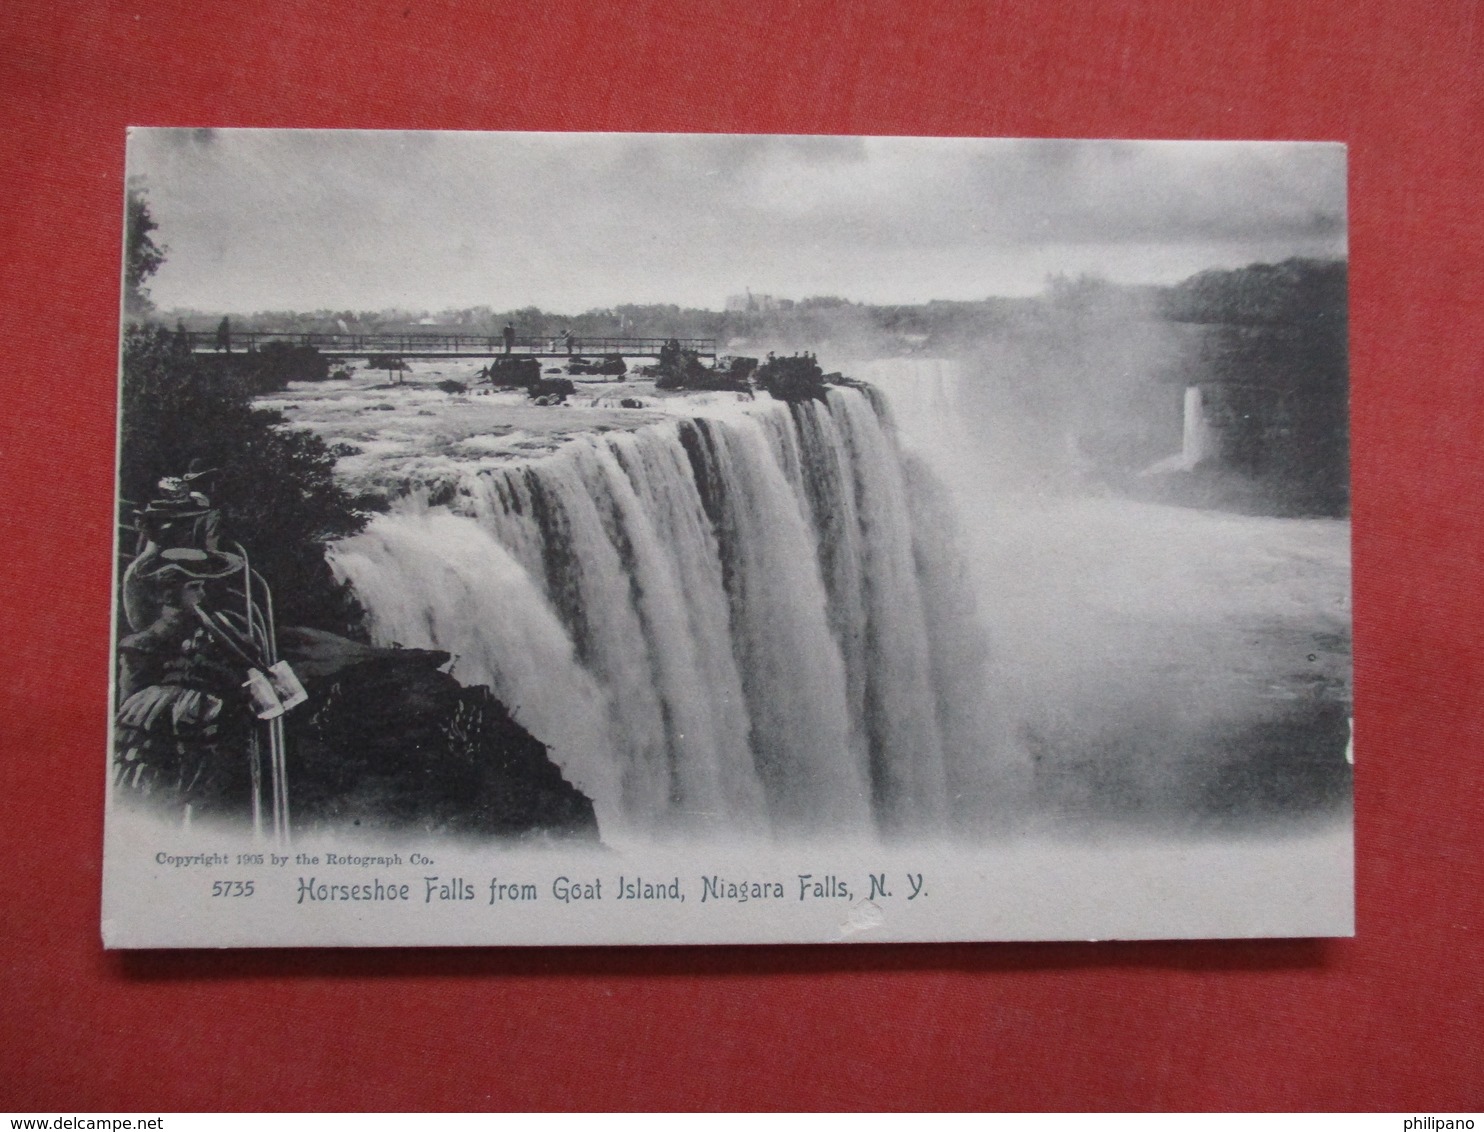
[{"xmin": 186, "ymin": 331, "xmax": 717, "ymax": 358}]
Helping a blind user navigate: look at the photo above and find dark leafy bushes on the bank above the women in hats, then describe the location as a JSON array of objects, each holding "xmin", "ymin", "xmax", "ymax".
[{"xmin": 119, "ymin": 326, "xmax": 375, "ymax": 632}]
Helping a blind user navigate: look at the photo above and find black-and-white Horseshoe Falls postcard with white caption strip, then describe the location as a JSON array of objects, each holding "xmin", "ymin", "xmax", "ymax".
[{"xmin": 101, "ymin": 129, "xmax": 1353, "ymax": 948}]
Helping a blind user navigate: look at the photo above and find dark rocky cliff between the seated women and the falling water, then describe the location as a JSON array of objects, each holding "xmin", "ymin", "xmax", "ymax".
[{"xmin": 280, "ymin": 629, "xmax": 597, "ymax": 838}]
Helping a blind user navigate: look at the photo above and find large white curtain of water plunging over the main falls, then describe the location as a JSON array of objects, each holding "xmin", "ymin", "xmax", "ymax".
[{"xmin": 331, "ymin": 389, "xmax": 1014, "ymax": 837}]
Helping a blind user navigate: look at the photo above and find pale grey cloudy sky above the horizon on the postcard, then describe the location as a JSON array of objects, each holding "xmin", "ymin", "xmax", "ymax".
[{"xmin": 128, "ymin": 129, "xmax": 1346, "ymax": 313}]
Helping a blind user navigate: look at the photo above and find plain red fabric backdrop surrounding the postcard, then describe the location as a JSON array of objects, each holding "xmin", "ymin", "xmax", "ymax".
[{"xmin": 0, "ymin": 0, "xmax": 1484, "ymax": 1111}]
